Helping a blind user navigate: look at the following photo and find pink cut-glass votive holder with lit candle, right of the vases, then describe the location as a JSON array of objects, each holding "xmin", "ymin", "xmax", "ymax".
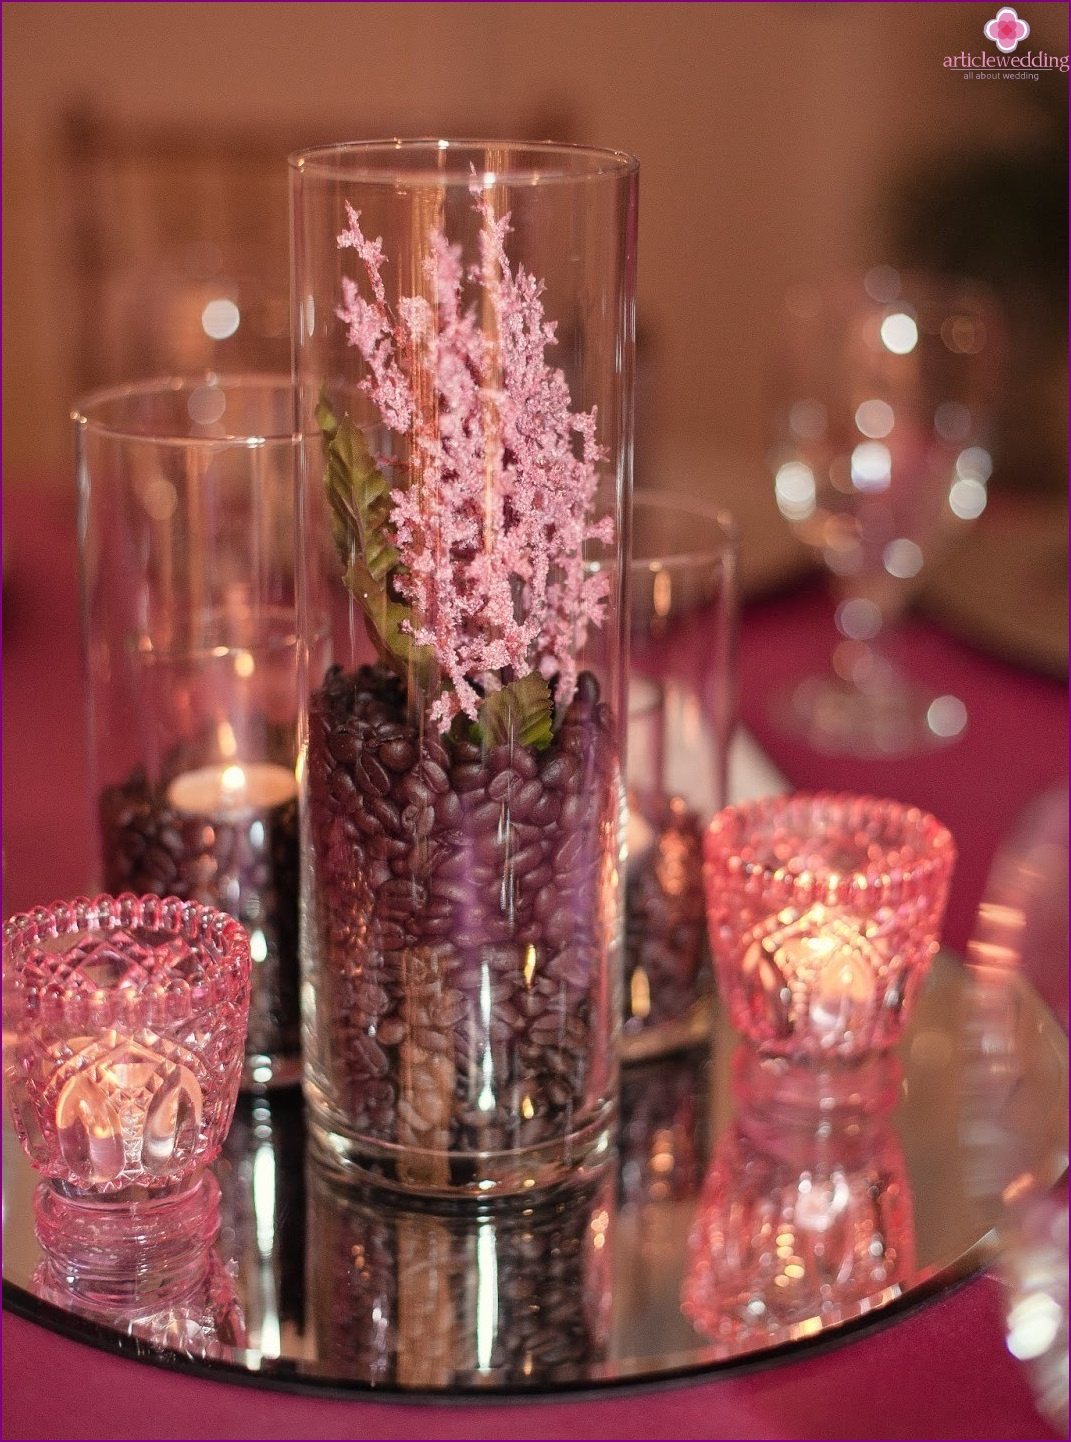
[{"xmin": 703, "ymin": 793, "xmax": 956, "ymax": 1061}]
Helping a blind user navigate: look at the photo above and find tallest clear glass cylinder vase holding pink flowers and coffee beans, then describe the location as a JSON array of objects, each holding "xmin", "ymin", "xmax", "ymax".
[{"xmin": 291, "ymin": 141, "xmax": 637, "ymax": 1195}]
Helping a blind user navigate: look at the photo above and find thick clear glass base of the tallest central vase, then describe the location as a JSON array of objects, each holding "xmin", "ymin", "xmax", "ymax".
[{"xmin": 306, "ymin": 1082, "xmax": 617, "ymax": 1200}]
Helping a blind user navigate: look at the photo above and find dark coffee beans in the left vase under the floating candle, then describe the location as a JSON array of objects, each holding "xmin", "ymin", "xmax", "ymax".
[{"xmin": 99, "ymin": 753, "xmax": 301, "ymax": 1057}]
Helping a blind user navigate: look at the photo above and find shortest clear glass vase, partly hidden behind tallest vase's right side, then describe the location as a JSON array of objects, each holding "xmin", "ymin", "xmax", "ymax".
[{"xmin": 621, "ymin": 490, "xmax": 737, "ymax": 1061}]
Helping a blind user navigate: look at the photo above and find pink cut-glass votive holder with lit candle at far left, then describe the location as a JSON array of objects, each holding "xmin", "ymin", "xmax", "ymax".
[{"xmin": 3, "ymin": 894, "xmax": 251, "ymax": 1201}]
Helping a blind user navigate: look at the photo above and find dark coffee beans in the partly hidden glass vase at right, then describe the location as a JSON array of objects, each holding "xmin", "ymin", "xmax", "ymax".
[{"xmin": 624, "ymin": 797, "xmax": 711, "ymax": 1035}]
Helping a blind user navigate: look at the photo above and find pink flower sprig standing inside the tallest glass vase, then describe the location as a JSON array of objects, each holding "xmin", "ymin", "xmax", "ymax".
[{"xmin": 337, "ymin": 185, "xmax": 614, "ymax": 730}]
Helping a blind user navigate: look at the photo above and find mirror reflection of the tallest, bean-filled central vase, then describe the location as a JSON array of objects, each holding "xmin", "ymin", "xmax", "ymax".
[{"xmin": 307, "ymin": 1165, "xmax": 616, "ymax": 1389}]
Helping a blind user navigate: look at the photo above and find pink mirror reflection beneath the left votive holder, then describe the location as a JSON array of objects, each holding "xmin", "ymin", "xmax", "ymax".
[{"xmin": 30, "ymin": 1172, "xmax": 245, "ymax": 1360}]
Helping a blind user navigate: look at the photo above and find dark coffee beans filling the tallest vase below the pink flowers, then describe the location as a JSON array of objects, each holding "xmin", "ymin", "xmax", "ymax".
[{"xmin": 308, "ymin": 666, "xmax": 620, "ymax": 1159}]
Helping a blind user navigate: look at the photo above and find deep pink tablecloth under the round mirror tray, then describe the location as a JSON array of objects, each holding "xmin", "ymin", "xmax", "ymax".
[{"xmin": 3, "ymin": 485, "xmax": 1067, "ymax": 1438}]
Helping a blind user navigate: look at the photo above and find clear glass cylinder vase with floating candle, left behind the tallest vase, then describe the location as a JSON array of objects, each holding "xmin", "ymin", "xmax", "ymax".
[{"xmin": 74, "ymin": 375, "xmax": 301, "ymax": 1087}]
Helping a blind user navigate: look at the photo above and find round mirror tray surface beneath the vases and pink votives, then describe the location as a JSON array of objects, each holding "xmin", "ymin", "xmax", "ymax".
[{"xmin": 3, "ymin": 955, "xmax": 1067, "ymax": 1396}]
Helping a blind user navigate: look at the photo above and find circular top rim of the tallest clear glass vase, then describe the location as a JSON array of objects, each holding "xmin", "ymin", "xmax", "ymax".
[{"xmin": 287, "ymin": 136, "xmax": 640, "ymax": 190}]
